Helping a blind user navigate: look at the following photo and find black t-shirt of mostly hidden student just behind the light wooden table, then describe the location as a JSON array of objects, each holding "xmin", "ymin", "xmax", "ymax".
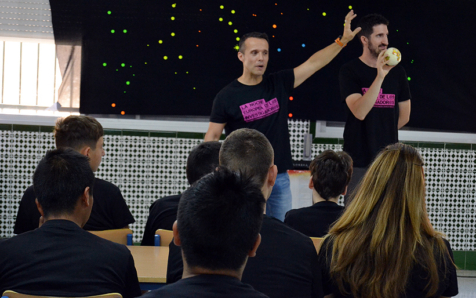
[{"xmin": 141, "ymin": 195, "xmax": 182, "ymax": 246}]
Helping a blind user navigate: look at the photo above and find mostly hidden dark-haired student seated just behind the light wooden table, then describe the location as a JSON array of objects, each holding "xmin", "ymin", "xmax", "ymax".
[{"xmin": 141, "ymin": 141, "xmax": 221, "ymax": 246}]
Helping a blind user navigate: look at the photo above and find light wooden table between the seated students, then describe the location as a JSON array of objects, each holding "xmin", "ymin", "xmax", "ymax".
[{"xmin": 127, "ymin": 246, "xmax": 169, "ymax": 290}]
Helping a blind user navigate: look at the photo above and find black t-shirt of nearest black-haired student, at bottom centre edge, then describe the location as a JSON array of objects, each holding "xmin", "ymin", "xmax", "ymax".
[{"xmin": 142, "ymin": 274, "xmax": 268, "ymax": 298}]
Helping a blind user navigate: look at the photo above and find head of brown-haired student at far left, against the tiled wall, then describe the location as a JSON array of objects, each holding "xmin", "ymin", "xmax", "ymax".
[{"xmin": 53, "ymin": 115, "xmax": 105, "ymax": 172}]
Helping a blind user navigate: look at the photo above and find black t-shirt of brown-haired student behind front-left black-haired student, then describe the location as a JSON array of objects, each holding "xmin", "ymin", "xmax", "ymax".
[{"xmin": 13, "ymin": 178, "xmax": 134, "ymax": 234}]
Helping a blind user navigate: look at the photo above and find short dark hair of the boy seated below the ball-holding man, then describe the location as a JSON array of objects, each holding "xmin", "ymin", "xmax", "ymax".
[{"xmin": 309, "ymin": 150, "xmax": 353, "ymax": 201}]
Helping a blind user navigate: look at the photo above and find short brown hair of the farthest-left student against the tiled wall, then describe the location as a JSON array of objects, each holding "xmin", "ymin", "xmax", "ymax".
[{"xmin": 53, "ymin": 115, "xmax": 104, "ymax": 150}]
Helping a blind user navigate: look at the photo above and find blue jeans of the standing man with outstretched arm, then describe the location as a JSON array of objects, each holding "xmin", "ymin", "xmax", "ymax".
[{"xmin": 266, "ymin": 172, "xmax": 293, "ymax": 221}]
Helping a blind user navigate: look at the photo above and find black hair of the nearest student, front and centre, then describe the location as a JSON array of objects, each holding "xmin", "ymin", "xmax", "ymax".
[{"xmin": 177, "ymin": 167, "xmax": 266, "ymax": 271}]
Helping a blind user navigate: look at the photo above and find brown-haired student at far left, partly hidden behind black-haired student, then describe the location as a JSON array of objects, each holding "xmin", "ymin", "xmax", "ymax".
[{"xmin": 13, "ymin": 116, "xmax": 134, "ymax": 234}]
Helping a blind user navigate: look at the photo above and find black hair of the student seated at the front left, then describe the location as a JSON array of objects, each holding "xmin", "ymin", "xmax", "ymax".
[{"xmin": 33, "ymin": 148, "xmax": 94, "ymax": 217}]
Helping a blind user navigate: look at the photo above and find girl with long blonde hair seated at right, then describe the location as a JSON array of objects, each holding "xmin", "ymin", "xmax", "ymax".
[{"xmin": 319, "ymin": 144, "xmax": 458, "ymax": 298}]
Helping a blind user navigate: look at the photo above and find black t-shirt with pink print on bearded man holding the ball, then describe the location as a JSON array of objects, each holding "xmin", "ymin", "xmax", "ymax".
[{"xmin": 339, "ymin": 58, "xmax": 411, "ymax": 168}]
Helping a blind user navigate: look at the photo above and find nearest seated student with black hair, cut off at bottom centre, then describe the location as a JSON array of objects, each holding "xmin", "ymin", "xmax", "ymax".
[{"xmin": 144, "ymin": 168, "xmax": 267, "ymax": 298}]
